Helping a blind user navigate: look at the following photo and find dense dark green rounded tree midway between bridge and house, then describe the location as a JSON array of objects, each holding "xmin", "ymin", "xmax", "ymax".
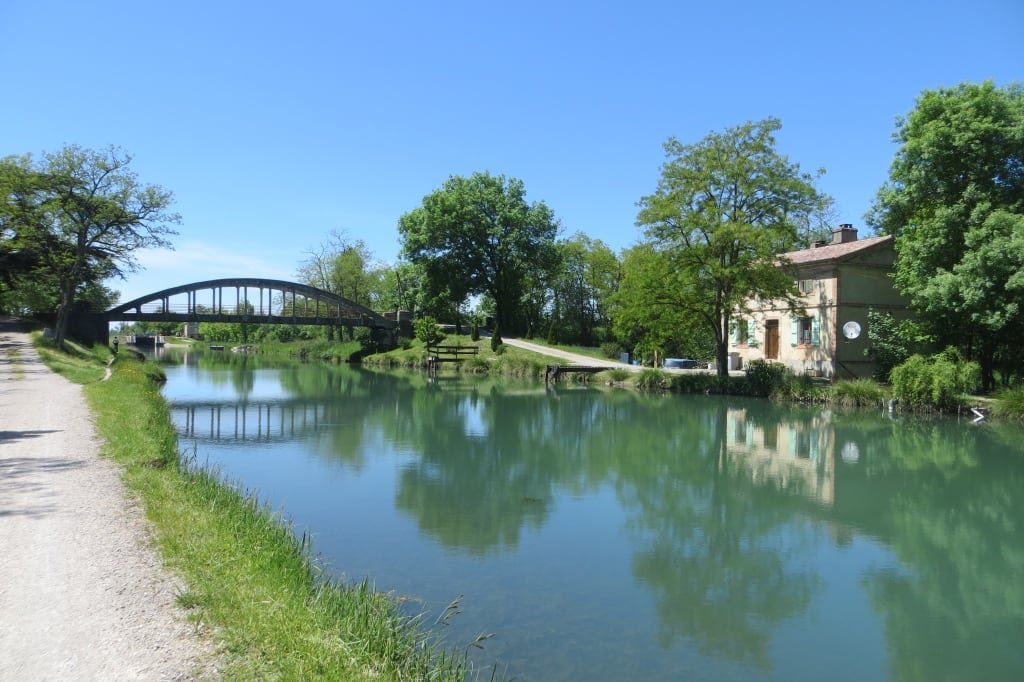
[{"xmin": 398, "ymin": 173, "xmax": 558, "ymax": 333}]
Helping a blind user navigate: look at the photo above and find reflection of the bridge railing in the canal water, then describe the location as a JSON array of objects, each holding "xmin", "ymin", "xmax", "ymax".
[{"xmin": 171, "ymin": 400, "xmax": 332, "ymax": 442}]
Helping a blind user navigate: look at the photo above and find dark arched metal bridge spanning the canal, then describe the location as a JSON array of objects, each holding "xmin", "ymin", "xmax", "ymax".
[{"xmin": 99, "ymin": 278, "xmax": 397, "ymax": 331}]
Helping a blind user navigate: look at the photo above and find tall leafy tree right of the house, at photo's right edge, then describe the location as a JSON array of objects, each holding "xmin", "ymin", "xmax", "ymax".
[{"xmin": 868, "ymin": 82, "xmax": 1024, "ymax": 389}]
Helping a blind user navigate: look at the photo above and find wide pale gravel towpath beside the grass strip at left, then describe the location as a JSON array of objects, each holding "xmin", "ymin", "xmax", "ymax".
[{"xmin": 0, "ymin": 319, "xmax": 216, "ymax": 681}]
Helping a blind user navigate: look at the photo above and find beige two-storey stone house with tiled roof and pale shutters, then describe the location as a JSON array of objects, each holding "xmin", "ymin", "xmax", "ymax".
[{"xmin": 729, "ymin": 224, "xmax": 907, "ymax": 379}]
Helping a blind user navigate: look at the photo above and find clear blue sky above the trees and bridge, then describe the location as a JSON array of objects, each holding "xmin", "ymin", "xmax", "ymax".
[{"xmin": 0, "ymin": 0, "xmax": 1024, "ymax": 300}]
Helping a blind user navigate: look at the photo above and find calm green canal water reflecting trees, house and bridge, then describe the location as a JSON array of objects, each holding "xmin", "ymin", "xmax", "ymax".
[{"xmin": 157, "ymin": 354, "xmax": 1024, "ymax": 682}]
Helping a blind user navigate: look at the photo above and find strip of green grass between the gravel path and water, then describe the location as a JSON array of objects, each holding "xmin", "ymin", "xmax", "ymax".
[{"xmin": 36, "ymin": 337, "xmax": 468, "ymax": 680}]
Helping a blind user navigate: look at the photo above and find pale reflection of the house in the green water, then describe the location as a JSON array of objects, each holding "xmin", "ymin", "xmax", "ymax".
[{"xmin": 726, "ymin": 409, "xmax": 836, "ymax": 506}]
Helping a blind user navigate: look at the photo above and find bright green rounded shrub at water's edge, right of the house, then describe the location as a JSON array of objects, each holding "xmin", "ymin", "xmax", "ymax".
[{"xmin": 890, "ymin": 348, "xmax": 981, "ymax": 411}]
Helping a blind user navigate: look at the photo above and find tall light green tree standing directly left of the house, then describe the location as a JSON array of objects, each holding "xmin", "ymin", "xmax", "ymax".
[{"xmin": 637, "ymin": 118, "xmax": 827, "ymax": 376}]
